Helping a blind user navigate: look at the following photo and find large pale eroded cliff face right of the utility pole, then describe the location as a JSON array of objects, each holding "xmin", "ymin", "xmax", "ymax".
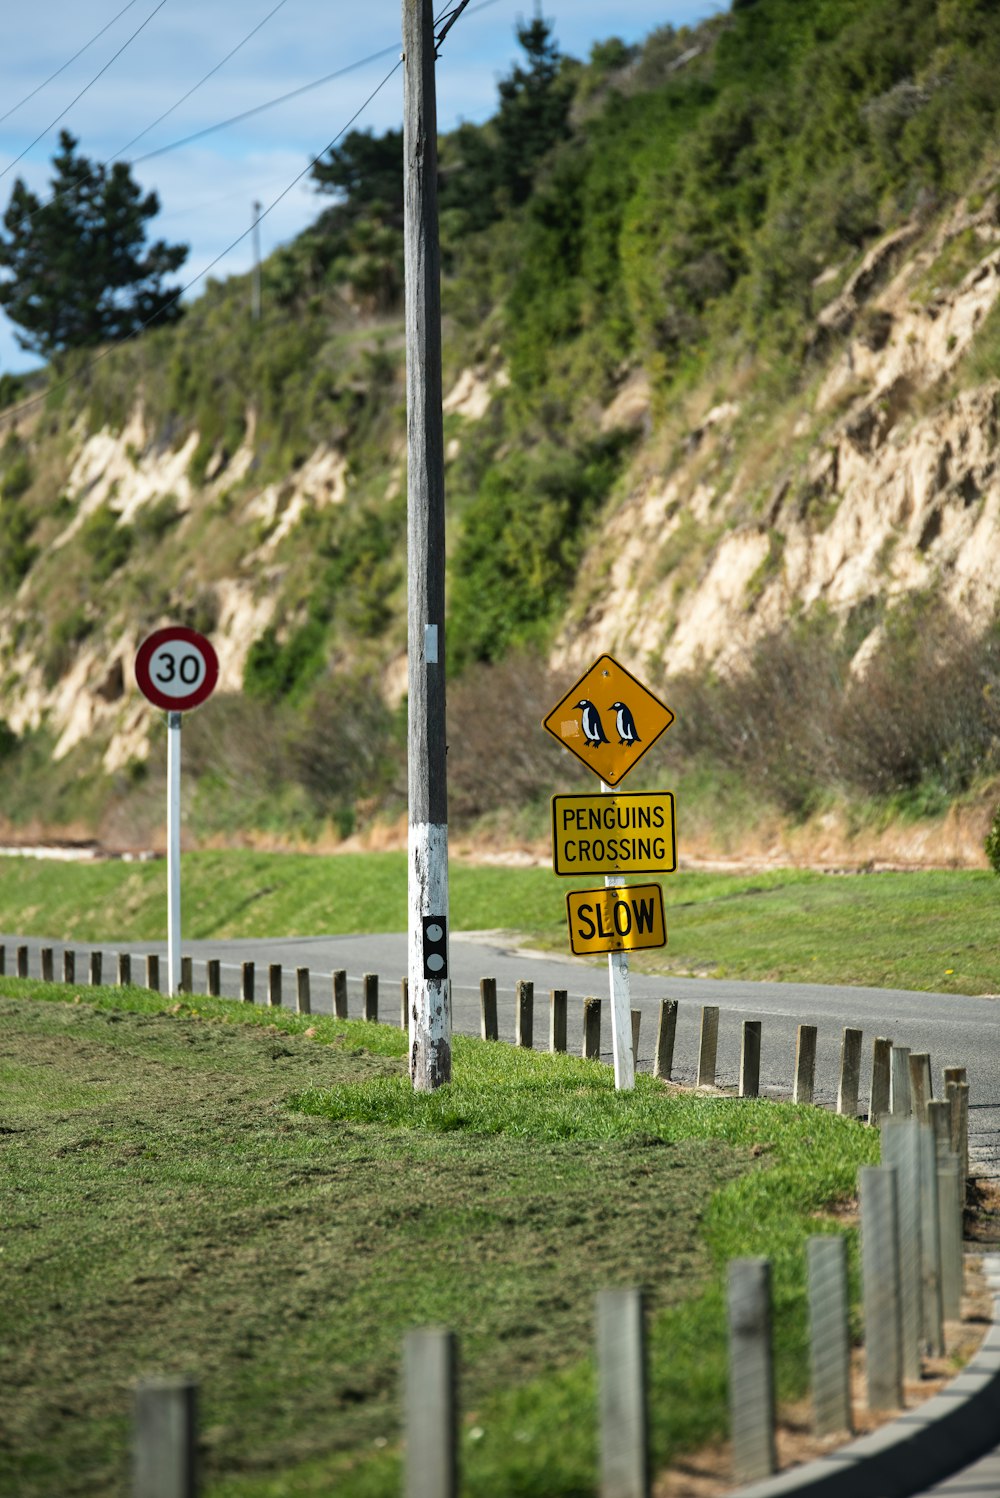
[{"xmin": 552, "ymin": 198, "xmax": 1000, "ymax": 674}]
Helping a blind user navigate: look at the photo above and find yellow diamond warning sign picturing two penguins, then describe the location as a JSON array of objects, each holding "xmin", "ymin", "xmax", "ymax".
[{"xmin": 542, "ymin": 656, "xmax": 674, "ymax": 785}]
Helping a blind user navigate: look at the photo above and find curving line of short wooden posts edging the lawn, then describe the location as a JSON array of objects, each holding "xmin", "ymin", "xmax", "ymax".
[{"xmin": 0, "ymin": 945, "xmax": 969, "ymax": 1498}]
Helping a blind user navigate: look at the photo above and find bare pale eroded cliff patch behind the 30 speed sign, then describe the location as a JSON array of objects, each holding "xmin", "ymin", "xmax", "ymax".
[{"xmin": 0, "ymin": 404, "xmax": 354, "ymax": 773}]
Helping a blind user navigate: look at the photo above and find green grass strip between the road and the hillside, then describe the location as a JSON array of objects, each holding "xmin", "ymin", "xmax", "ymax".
[{"xmin": 0, "ymin": 852, "xmax": 1000, "ymax": 993}]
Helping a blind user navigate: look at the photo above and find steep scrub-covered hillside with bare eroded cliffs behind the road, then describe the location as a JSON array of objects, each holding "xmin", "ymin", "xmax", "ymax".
[{"xmin": 0, "ymin": 0, "xmax": 1000, "ymax": 861}]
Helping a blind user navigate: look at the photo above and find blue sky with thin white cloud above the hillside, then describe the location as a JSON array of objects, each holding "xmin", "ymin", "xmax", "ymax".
[{"xmin": 0, "ymin": 0, "xmax": 725, "ymax": 373}]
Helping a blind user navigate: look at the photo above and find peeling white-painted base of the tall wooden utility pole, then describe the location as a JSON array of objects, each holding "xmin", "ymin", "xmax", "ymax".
[{"xmin": 407, "ymin": 822, "xmax": 452, "ymax": 1092}]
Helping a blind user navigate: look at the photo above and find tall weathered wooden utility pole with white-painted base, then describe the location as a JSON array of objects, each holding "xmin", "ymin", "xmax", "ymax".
[{"xmin": 403, "ymin": 0, "xmax": 452, "ymax": 1092}]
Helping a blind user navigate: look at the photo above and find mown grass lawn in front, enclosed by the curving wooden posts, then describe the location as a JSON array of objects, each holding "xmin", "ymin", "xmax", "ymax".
[{"xmin": 0, "ymin": 978, "xmax": 877, "ymax": 1498}]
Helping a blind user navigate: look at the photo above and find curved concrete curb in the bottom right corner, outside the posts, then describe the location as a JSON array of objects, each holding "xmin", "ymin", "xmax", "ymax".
[{"xmin": 729, "ymin": 1254, "xmax": 1000, "ymax": 1498}]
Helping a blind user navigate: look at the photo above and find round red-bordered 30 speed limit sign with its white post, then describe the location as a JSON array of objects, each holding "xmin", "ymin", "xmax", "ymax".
[{"xmin": 135, "ymin": 625, "xmax": 219, "ymax": 993}]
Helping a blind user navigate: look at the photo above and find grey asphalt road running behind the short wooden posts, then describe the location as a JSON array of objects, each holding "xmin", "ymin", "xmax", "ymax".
[{"xmin": 0, "ymin": 933, "xmax": 1000, "ymax": 1179}]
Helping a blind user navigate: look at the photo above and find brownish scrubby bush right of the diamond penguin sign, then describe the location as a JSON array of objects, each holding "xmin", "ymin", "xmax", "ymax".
[{"xmin": 669, "ymin": 602, "xmax": 1000, "ymax": 816}]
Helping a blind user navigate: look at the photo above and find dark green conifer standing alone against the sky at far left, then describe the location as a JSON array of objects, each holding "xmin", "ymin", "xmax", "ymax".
[{"xmin": 0, "ymin": 130, "xmax": 187, "ymax": 358}]
